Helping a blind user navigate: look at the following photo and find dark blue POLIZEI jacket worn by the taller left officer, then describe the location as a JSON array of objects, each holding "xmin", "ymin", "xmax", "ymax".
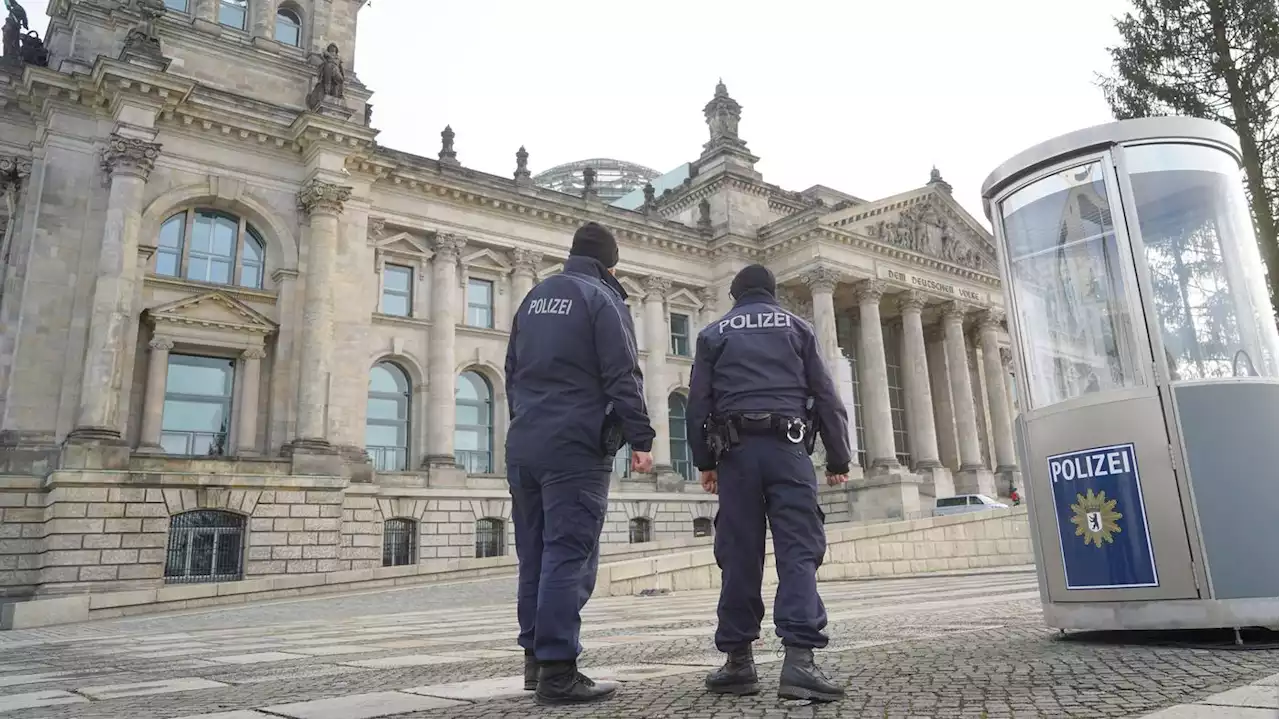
[{"xmin": 506, "ymin": 256, "xmax": 654, "ymax": 470}]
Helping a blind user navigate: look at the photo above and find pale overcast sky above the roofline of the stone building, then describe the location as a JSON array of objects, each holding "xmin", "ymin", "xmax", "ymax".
[{"xmin": 40, "ymin": 0, "xmax": 1129, "ymax": 221}]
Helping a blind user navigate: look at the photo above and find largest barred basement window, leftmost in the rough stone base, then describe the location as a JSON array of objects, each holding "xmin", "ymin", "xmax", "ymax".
[{"xmin": 164, "ymin": 509, "xmax": 244, "ymax": 583}]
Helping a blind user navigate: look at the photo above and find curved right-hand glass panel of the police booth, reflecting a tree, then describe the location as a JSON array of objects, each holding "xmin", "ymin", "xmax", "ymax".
[{"xmin": 1124, "ymin": 143, "xmax": 1280, "ymax": 381}]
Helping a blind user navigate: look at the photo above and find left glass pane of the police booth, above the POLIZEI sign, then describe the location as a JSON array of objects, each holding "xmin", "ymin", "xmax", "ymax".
[{"xmin": 1001, "ymin": 162, "xmax": 1142, "ymax": 407}]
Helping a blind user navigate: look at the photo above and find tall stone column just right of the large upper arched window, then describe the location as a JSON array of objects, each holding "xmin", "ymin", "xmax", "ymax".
[{"xmin": 293, "ymin": 179, "xmax": 351, "ymax": 449}]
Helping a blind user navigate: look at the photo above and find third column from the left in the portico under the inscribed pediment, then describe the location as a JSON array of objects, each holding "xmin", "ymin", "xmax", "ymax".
[{"xmin": 897, "ymin": 290, "xmax": 955, "ymax": 496}]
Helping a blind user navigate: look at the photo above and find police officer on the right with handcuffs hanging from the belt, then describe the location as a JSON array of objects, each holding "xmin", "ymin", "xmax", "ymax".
[{"xmin": 687, "ymin": 265, "xmax": 850, "ymax": 701}]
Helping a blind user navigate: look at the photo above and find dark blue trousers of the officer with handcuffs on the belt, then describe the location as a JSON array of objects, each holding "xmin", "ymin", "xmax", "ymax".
[{"xmin": 716, "ymin": 435, "xmax": 827, "ymax": 652}]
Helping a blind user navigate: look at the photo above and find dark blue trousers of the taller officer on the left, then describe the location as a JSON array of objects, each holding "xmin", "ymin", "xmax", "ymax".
[{"xmin": 507, "ymin": 464, "xmax": 609, "ymax": 661}]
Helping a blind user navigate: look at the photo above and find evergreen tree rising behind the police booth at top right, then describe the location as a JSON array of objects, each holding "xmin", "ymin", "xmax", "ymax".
[{"xmin": 1101, "ymin": 0, "xmax": 1280, "ymax": 311}]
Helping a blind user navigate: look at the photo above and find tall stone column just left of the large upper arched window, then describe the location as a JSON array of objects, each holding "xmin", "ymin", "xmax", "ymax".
[{"xmin": 68, "ymin": 134, "xmax": 160, "ymax": 441}]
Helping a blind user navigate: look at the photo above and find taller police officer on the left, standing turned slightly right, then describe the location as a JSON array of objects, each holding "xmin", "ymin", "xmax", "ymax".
[{"xmin": 506, "ymin": 223, "xmax": 654, "ymax": 704}]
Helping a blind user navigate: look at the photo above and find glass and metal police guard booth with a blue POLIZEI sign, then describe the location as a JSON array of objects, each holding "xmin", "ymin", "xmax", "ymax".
[{"xmin": 983, "ymin": 118, "xmax": 1280, "ymax": 629}]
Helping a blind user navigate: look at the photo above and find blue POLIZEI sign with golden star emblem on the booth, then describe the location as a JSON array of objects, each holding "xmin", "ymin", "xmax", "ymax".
[{"xmin": 1048, "ymin": 444, "xmax": 1160, "ymax": 590}]
